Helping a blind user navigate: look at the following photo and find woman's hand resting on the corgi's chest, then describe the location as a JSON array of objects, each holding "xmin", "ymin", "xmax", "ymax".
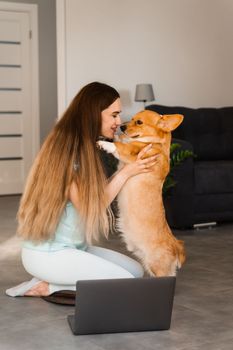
[{"xmin": 120, "ymin": 144, "xmax": 158, "ymax": 179}]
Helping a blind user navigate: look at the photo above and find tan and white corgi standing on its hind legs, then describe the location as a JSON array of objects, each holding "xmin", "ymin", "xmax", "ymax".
[{"xmin": 98, "ymin": 110, "xmax": 185, "ymax": 277}]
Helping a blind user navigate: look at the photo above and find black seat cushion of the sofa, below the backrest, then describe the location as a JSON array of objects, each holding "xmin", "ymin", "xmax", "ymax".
[{"xmin": 194, "ymin": 161, "xmax": 233, "ymax": 194}]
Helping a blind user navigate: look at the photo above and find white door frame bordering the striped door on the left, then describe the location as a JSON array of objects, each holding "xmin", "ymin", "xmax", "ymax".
[{"xmin": 0, "ymin": 1, "xmax": 40, "ymax": 158}]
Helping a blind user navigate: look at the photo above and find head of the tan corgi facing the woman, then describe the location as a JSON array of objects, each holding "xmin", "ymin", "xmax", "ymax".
[{"xmin": 120, "ymin": 110, "xmax": 184, "ymax": 142}]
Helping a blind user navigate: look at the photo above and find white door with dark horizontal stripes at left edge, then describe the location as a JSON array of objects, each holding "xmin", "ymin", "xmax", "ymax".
[{"xmin": 0, "ymin": 10, "xmax": 39, "ymax": 195}]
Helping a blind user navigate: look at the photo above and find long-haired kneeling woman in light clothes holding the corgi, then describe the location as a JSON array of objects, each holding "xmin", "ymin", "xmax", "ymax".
[{"xmin": 6, "ymin": 82, "xmax": 155, "ymax": 296}]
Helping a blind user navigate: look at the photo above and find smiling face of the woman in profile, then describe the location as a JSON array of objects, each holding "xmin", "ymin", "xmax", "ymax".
[{"xmin": 101, "ymin": 98, "xmax": 121, "ymax": 139}]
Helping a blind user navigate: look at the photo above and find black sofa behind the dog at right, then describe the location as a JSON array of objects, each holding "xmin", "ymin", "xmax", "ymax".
[{"xmin": 146, "ymin": 104, "xmax": 233, "ymax": 228}]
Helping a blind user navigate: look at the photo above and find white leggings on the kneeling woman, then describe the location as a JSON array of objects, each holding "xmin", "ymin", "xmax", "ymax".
[{"xmin": 22, "ymin": 246, "xmax": 144, "ymax": 294}]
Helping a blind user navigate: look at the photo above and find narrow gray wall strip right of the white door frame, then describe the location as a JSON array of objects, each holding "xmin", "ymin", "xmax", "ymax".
[{"xmin": 4, "ymin": 0, "xmax": 57, "ymax": 142}]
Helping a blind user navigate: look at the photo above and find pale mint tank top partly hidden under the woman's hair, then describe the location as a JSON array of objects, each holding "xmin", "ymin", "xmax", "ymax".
[{"xmin": 23, "ymin": 202, "xmax": 87, "ymax": 252}]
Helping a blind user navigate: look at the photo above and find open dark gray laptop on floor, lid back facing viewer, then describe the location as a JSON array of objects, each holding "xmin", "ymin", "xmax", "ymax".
[{"xmin": 68, "ymin": 277, "xmax": 176, "ymax": 335}]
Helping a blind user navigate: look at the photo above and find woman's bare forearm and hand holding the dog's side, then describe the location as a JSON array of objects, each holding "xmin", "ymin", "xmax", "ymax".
[{"xmin": 106, "ymin": 145, "xmax": 158, "ymax": 204}]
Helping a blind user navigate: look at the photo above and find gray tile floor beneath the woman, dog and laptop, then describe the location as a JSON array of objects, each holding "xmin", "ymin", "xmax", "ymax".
[{"xmin": 0, "ymin": 196, "xmax": 233, "ymax": 350}]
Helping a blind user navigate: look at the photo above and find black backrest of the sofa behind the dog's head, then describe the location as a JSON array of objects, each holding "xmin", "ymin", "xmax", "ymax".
[{"xmin": 146, "ymin": 105, "xmax": 233, "ymax": 160}]
